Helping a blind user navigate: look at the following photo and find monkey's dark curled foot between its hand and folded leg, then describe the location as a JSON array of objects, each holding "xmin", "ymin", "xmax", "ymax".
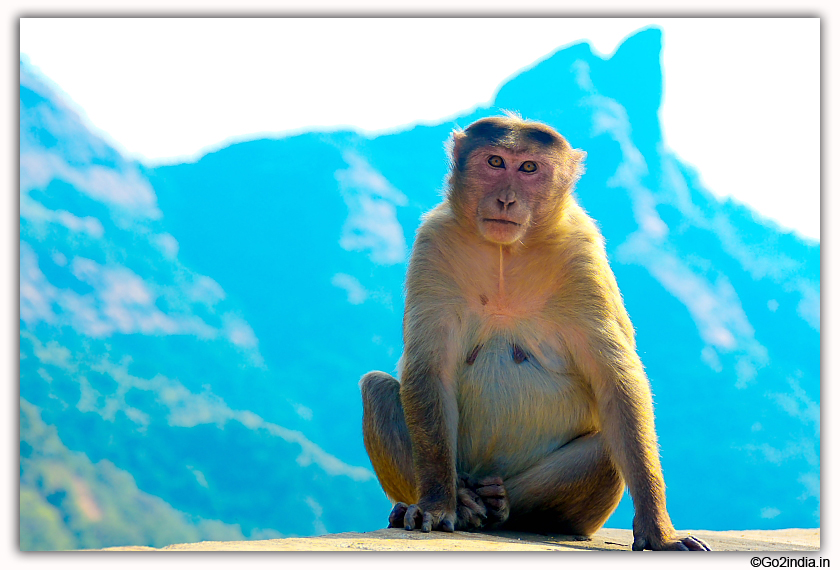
[{"xmin": 456, "ymin": 475, "xmax": 510, "ymax": 530}]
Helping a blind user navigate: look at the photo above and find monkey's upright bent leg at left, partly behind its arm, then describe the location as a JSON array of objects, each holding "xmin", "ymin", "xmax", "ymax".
[{"xmin": 359, "ymin": 371, "xmax": 418, "ymax": 504}]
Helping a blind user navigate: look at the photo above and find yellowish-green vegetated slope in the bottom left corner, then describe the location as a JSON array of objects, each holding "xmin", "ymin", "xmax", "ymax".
[{"xmin": 20, "ymin": 399, "xmax": 279, "ymax": 551}]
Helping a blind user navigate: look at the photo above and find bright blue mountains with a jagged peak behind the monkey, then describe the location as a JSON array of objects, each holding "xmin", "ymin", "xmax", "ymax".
[{"xmin": 20, "ymin": 29, "xmax": 820, "ymax": 549}]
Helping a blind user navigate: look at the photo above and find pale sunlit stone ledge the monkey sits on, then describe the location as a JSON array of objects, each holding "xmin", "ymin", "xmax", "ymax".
[{"xmin": 104, "ymin": 528, "xmax": 820, "ymax": 552}]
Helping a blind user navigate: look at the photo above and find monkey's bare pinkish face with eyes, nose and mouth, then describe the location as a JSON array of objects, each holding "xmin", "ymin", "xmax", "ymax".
[{"xmin": 465, "ymin": 146, "xmax": 554, "ymax": 245}]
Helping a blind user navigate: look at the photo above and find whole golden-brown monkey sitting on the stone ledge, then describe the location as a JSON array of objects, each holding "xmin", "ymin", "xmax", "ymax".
[{"xmin": 360, "ymin": 114, "xmax": 710, "ymax": 550}]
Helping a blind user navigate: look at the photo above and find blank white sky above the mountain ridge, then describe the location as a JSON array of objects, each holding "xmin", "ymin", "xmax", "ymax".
[{"xmin": 20, "ymin": 18, "xmax": 820, "ymax": 239}]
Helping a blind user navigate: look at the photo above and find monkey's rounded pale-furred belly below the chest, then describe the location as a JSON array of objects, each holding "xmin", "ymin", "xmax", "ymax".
[{"xmin": 457, "ymin": 337, "xmax": 596, "ymax": 478}]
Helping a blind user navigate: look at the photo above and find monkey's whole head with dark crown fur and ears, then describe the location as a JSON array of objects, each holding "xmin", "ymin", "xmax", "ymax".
[{"xmin": 447, "ymin": 116, "xmax": 586, "ymax": 245}]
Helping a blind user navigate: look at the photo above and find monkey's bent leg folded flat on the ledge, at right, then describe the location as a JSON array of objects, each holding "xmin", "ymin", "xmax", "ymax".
[{"xmin": 504, "ymin": 433, "xmax": 624, "ymax": 536}]
